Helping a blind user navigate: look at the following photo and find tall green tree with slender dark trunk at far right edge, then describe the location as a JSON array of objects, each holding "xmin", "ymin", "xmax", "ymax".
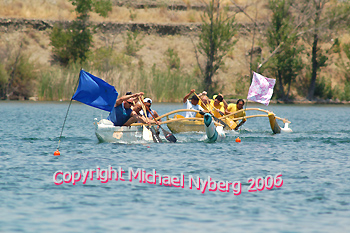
[{"xmin": 294, "ymin": 0, "xmax": 350, "ymax": 100}]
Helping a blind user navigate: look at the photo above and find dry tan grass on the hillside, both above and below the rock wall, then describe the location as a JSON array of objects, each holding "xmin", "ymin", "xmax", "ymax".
[{"xmin": 0, "ymin": 0, "xmax": 350, "ymax": 98}]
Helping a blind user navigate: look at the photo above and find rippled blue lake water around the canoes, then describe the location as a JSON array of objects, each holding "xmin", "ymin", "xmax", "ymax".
[{"xmin": 0, "ymin": 102, "xmax": 350, "ymax": 232}]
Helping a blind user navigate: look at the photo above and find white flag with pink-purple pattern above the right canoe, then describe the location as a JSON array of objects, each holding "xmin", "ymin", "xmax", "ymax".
[{"xmin": 247, "ymin": 72, "xmax": 276, "ymax": 106}]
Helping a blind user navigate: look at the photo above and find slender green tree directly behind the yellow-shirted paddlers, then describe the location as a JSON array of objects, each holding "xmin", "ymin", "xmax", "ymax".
[{"xmin": 196, "ymin": 0, "xmax": 238, "ymax": 95}]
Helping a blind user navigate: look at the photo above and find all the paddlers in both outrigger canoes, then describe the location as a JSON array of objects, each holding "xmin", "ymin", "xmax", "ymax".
[{"xmin": 107, "ymin": 89, "xmax": 246, "ymax": 130}]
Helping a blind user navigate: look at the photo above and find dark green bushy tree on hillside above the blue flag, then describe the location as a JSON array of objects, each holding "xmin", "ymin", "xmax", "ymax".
[{"xmin": 50, "ymin": 0, "xmax": 112, "ymax": 65}]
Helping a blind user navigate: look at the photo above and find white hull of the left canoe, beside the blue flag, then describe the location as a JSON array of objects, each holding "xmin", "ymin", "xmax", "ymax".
[{"xmin": 94, "ymin": 118, "xmax": 153, "ymax": 143}]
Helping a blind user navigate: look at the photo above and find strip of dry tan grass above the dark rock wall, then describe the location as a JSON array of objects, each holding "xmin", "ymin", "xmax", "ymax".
[{"xmin": 0, "ymin": 0, "xmax": 268, "ymax": 23}]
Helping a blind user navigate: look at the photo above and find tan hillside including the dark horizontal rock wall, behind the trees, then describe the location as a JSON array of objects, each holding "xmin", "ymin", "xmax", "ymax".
[{"xmin": 0, "ymin": 0, "xmax": 348, "ymax": 103}]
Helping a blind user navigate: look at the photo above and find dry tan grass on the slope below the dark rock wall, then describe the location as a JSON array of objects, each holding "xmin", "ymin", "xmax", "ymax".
[{"xmin": 0, "ymin": 24, "xmax": 339, "ymax": 97}]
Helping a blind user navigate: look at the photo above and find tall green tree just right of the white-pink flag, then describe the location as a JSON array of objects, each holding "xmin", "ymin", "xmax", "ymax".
[{"xmin": 266, "ymin": 0, "xmax": 303, "ymax": 101}]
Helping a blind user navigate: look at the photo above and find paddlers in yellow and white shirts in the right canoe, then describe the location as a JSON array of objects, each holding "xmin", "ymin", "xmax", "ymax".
[{"xmin": 183, "ymin": 89, "xmax": 246, "ymax": 130}]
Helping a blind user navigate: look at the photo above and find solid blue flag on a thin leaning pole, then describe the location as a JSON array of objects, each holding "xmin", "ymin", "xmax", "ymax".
[{"xmin": 72, "ymin": 70, "xmax": 118, "ymax": 112}]
